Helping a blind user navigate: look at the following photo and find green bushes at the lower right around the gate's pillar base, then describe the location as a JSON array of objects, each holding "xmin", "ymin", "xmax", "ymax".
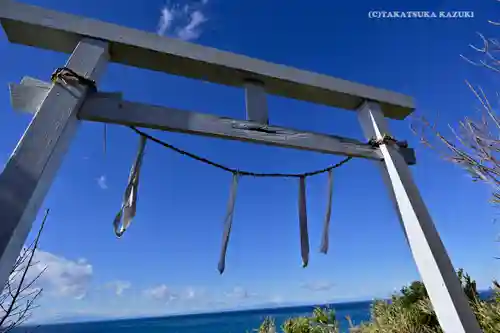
[{"xmin": 256, "ymin": 269, "xmax": 500, "ymax": 333}]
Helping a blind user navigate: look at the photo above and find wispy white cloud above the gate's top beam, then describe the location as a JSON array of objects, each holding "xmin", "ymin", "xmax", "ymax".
[{"xmin": 157, "ymin": 0, "xmax": 208, "ymax": 41}]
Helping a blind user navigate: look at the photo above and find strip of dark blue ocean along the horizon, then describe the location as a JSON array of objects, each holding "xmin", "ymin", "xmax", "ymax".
[{"xmin": 17, "ymin": 302, "xmax": 371, "ymax": 333}]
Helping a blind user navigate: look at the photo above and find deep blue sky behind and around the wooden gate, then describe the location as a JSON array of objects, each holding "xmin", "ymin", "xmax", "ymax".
[{"xmin": 0, "ymin": 0, "xmax": 500, "ymax": 320}]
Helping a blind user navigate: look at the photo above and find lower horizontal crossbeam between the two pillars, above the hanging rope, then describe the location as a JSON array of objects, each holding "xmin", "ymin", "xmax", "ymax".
[{"xmin": 78, "ymin": 94, "xmax": 381, "ymax": 160}]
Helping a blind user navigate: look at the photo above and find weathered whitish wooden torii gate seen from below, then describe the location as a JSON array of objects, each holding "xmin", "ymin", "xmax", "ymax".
[{"xmin": 0, "ymin": 0, "xmax": 481, "ymax": 333}]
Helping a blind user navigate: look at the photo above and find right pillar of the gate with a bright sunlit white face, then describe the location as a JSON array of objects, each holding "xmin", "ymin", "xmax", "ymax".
[{"xmin": 358, "ymin": 102, "xmax": 481, "ymax": 333}]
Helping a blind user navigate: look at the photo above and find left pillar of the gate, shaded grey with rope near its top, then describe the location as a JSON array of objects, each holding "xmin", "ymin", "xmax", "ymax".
[{"xmin": 0, "ymin": 39, "xmax": 109, "ymax": 285}]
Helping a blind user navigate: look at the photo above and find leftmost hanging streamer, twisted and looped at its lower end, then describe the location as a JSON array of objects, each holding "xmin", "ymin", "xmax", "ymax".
[{"xmin": 113, "ymin": 136, "xmax": 147, "ymax": 238}]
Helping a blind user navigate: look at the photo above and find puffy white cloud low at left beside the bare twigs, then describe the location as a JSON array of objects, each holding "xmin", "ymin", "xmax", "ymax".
[{"xmin": 25, "ymin": 250, "xmax": 93, "ymax": 299}]
